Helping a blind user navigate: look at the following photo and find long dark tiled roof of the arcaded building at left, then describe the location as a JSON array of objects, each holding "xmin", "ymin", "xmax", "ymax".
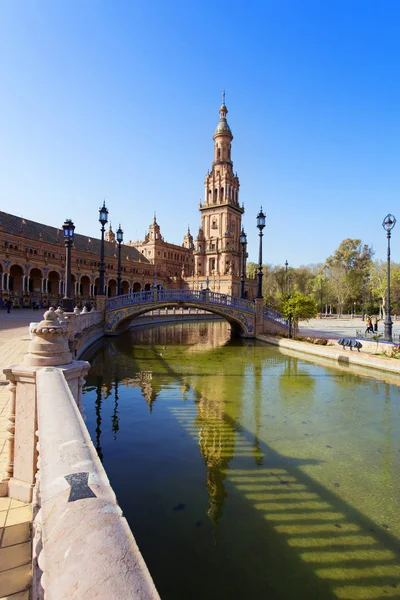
[{"xmin": 0, "ymin": 211, "xmax": 149, "ymax": 263}]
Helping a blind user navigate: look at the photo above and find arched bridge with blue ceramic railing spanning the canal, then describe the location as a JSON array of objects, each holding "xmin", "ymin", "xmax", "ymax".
[{"xmin": 104, "ymin": 289, "xmax": 288, "ymax": 337}]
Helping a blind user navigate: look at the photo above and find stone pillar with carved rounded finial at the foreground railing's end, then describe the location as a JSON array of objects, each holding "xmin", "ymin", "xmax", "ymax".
[{"xmin": 3, "ymin": 308, "xmax": 89, "ymax": 502}]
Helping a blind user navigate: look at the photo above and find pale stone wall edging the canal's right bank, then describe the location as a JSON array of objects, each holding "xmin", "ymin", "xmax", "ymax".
[{"xmin": 256, "ymin": 335, "xmax": 400, "ymax": 375}]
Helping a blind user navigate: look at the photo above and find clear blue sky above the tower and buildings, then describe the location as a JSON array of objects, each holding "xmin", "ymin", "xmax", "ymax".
[{"xmin": 0, "ymin": 0, "xmax": 400, "ymax": 266}]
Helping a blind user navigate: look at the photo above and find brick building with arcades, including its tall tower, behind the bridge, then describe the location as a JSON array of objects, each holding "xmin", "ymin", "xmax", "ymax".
[{"xmin": 0, "ymin": 97, "xmax": 256, "ymax": 307}]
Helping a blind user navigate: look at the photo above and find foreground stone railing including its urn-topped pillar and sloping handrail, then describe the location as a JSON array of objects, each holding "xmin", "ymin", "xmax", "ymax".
[{"xmin": 3, "ymin": 309, "xmax": 159, "ymax": 600}]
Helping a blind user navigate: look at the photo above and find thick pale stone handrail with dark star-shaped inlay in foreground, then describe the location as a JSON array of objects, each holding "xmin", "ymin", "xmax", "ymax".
[{"xmin": 33, "ymin": 367, "xmax": 159, "ymax": 600}]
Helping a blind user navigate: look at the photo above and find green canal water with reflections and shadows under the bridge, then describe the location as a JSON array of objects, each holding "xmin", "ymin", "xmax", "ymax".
[{"xmin": 80, "ymin": 322, "xmax": 400, "ymax": 600}]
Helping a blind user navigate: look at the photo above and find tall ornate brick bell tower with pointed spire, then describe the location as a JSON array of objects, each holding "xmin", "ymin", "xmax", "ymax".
[{"xmin": 194, "ymin": 92, "xmax": 244, "ymax": 278}]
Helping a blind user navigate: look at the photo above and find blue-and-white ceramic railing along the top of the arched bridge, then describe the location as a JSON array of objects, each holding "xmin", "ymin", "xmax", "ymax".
[{"xmin": 106, "ymin": 289, "xmax": 255, "ymax": 313}]
